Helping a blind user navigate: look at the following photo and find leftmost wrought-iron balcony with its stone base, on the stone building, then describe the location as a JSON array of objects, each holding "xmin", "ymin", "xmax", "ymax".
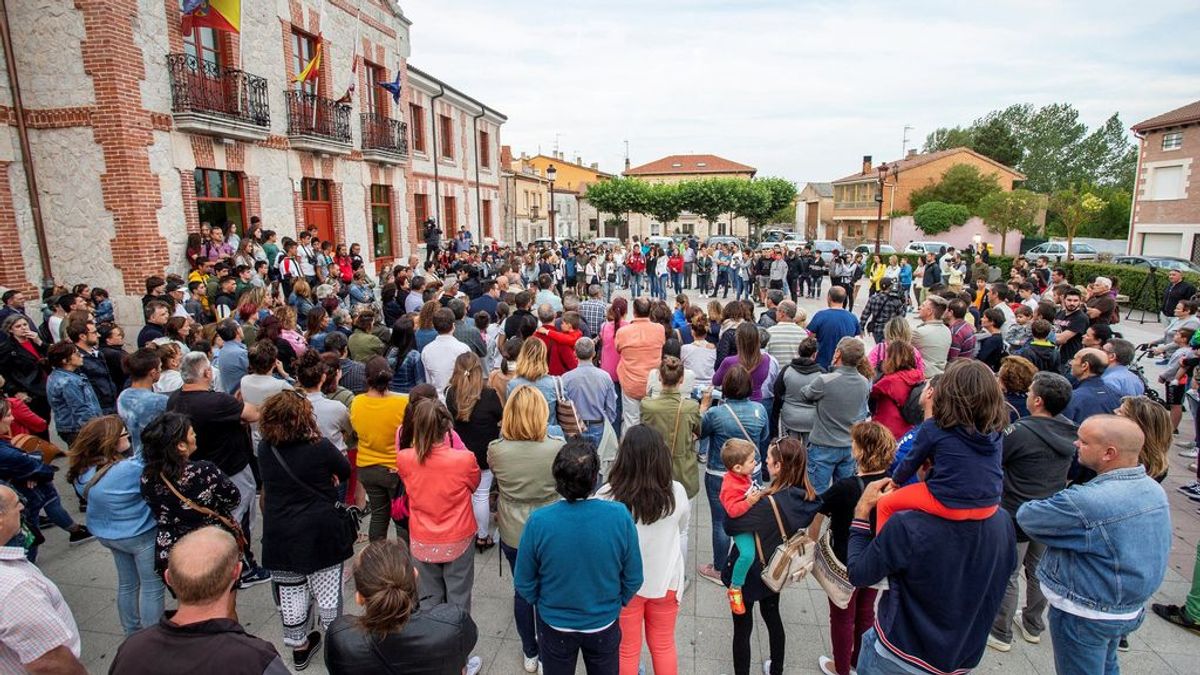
[{"xmin": 167, "ymin": 54, "xmax": 271, "ymax": 141}]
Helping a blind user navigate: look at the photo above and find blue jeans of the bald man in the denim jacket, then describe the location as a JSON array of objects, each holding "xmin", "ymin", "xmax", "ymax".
[{"xmin": 1050, "ymin": 605, "xmax": 1146, "ymax": 675}]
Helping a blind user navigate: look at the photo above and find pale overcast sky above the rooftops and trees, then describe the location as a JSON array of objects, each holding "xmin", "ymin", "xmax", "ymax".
[{"xmin": 402, "ymin": 0, "xmax": 1200, "ymax": 185}]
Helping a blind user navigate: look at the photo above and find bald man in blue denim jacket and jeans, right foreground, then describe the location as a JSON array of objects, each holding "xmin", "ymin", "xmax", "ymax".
[{"xmin": 1016, "ymin": 414, "xmax": 1171, "ymax": 675}]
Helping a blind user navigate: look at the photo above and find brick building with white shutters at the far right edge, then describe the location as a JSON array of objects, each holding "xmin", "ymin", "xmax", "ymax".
[{"xmin": 1129, "ymin": 101, "xmax": 1200, "ymax": 261}]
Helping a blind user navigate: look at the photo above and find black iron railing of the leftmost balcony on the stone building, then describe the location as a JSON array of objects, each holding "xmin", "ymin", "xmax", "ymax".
[{"xmin": 167, "ymin": 54, "xmax": 271, "ymax": 130}]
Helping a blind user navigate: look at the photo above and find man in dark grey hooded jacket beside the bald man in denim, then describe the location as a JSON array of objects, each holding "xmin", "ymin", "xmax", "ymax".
[{"xmin": 988, "ymin": 371, "xmax": 1079, "ymax": 651}]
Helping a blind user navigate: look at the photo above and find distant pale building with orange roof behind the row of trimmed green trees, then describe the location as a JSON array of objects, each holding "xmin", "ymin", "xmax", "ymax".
[{"xmin": 624, "ymin": 155, "xmax": 758, "ymax": 239}]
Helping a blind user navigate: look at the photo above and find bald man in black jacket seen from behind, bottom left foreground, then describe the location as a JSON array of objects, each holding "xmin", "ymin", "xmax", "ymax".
[{"xmin": 109, "ymin": 527, "xmax": 291, "ymax": 675}]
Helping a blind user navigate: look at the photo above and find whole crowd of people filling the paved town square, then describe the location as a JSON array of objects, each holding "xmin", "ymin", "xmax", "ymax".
[{"xmin": 0, "ymin": 219, "xmax": 1200, "ymax": 675}]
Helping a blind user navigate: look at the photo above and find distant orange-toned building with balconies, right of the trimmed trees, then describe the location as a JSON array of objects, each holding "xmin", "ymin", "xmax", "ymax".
[{"xmin": 824, "ymin": 148, "xmax": 1025, "ymax": 243}]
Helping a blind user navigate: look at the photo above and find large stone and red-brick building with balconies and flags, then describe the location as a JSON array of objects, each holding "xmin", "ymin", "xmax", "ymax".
[{"xmin": 0, "ymin": 0, "xmax": 505, "ymax": 325}]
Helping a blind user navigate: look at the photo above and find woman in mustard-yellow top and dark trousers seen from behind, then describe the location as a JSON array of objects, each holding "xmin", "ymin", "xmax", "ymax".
[{"xmin": 350, "ymin": 357, "xmax": 408, "ymax": 542}]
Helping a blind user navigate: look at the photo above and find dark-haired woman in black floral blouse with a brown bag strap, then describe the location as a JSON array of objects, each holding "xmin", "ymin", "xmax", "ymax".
[{"xmin": 142, "ymin": 412, "xmax": 240, "ymax": 574}]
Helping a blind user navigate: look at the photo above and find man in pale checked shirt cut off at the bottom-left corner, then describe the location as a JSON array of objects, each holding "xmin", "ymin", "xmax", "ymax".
[{"xmin": 0, "ymin": 483, "xmax": 86, "ymax": 675}]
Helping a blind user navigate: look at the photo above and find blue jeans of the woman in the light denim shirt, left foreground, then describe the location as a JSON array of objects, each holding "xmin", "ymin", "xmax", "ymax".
[{"xmin": 97, "ymin": 527, "xmax": 166, "ymax": 635}]
